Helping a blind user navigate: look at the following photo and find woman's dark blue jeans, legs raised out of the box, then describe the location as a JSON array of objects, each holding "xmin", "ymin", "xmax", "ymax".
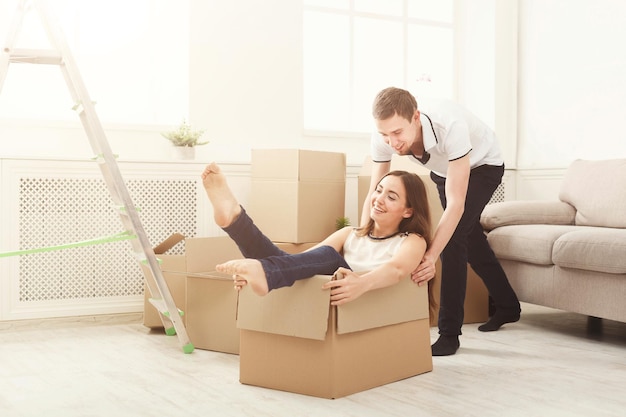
[{"xmin": 222, "ymin": 207, "xmax": 351, "ymax": 291}]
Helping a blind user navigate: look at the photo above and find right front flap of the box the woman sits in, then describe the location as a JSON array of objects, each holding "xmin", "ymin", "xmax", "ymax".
[{"xmin": 337, "ymin": 278, "xmax": 428, "ymax": 334}]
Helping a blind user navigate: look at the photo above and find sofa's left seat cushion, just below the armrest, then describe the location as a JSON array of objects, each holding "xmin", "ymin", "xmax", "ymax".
[{"xmin": 487, "ymin": 225, "xmax": 576, "ymax": 265}]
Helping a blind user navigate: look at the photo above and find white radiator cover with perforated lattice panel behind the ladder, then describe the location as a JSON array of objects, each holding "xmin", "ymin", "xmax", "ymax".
[{"xmin": 0, "ymin": 160, "xmax": 212, "ymax": 320}]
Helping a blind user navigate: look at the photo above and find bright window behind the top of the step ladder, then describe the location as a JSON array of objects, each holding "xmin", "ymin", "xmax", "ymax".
[{"xmin": 0, "ymin": 0, "xmax": 189, "ymax": 125}]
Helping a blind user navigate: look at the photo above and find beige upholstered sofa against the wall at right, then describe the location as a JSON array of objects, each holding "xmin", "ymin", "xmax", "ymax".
[{"xmin": 481, "ymin": 159, "xmax": 626, "ymax": 322}]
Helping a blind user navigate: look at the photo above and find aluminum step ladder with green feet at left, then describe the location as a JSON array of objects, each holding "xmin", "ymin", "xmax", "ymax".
[{"xmin": 0, "ymin": 0, "xmax": 194, "ymax": 353}]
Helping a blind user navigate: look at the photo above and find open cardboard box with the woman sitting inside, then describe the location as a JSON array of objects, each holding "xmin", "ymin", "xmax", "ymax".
[{"xmin": 237, "ymin": 275, "xmax": 432, "ymax": 398}]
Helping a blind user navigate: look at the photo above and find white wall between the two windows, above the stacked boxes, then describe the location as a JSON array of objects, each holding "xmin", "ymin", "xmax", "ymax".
[{"xmin": 185, "ymin": 0, "xmax": 369, "ymax": 164}]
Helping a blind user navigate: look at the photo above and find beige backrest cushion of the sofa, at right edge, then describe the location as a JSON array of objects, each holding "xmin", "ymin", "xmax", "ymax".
[{"xmin": 559, "ymin": 159, "xmax": 626, "ymax": 228}]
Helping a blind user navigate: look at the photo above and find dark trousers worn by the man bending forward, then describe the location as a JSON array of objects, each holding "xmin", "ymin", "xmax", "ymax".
[{"xmin": 430, "ymin": 165, "xmax": 520, "ymax": 336}]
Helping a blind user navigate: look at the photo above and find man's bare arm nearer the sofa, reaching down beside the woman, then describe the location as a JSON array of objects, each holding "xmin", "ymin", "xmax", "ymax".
[{"xmin": 411, "ymin": 155, "xmax": 470, "ymax": 284}]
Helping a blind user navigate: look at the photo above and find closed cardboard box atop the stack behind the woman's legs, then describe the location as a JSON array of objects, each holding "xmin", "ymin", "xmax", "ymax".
[{"xmin": 246, "ymin": 149, "xmax": 346, "ymax": 243}]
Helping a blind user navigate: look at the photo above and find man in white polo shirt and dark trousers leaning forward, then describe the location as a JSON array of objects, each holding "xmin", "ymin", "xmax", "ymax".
[{"xmin": 362, "ymin": 87, "xmax": 521, "ymax": 356}]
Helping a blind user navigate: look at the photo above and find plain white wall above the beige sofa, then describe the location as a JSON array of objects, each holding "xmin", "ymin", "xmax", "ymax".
[{"xmin": 517, "ymin": 0, "xmax": 626, "ymax": 169}]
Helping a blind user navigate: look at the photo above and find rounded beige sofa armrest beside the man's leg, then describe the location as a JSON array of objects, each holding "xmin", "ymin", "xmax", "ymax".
[{"xmin": 480, "ymin": 200, "xmax": 576, "ymax": 231}]
